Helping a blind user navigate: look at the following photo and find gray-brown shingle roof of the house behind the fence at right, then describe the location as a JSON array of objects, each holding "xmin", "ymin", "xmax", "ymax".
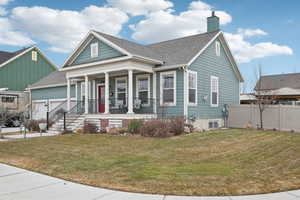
[{"xmin": 255, "ymin": 73, "xmax": 300, "ymax": 90}]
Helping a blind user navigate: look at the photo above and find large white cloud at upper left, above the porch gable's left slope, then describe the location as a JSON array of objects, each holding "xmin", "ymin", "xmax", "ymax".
[{"xmin": 10, "ymin": 6, "xmax": 128, "ymax": 53}]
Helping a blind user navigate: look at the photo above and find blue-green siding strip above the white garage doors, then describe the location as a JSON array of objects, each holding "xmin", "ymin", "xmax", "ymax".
[{"xmin": 31, "ymin": 85, "xmax": 75, "ymax": 100}]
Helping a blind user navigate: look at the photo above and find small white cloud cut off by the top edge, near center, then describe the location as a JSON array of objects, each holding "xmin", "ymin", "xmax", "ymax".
[{"xmin": 107, "ymin": 0, "xmax": 173, "ymax": 16}]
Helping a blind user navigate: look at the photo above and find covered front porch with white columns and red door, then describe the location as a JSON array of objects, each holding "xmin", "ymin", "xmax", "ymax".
[{"xmin": 67, "ymin": 61, "xmax": 157, "ymax": 118}]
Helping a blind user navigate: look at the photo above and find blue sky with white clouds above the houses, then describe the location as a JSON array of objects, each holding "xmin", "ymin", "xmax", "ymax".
[{"xmin": 0, "ymin": 0, "xmax": 300, "ymax": 92}]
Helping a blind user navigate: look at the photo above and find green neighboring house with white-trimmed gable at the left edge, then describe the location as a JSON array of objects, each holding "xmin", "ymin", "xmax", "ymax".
[{"xmin": 0, "ymin": 46, "xmax": 56, "ymax": 111}]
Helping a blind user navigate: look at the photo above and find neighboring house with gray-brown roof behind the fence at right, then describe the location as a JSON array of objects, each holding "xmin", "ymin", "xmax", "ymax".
[{"xmin": 254, "ymin": 73, "xmax": 300, "ymax": 105}]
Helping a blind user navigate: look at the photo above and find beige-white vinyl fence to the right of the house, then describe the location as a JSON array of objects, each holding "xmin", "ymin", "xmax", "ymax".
[{"xmin": 228, "ymin": 105, "xmax": 300, "ymax": 132}]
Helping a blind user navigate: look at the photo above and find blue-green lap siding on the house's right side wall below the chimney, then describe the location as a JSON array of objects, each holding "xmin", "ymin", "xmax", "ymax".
[{"xmin": 188, "ymin": 39, "xmax": 239, "ymax": 119}]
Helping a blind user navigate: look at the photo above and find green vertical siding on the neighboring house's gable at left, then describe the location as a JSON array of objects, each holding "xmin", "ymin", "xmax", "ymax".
[{"xmin": 0, "ymin": 48, "xmax": 56, "ymax": 91}]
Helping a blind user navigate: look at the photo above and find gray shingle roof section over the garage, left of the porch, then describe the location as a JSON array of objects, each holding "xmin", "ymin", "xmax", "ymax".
[{"xmin": 29, "ymin": 71, "xmax": 67, "ymax": 88}]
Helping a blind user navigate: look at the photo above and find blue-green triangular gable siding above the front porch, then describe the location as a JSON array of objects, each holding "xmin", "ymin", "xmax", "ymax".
[{"xmin": 72, "ymin": 38, "xmax": 123, "ymax": 65}]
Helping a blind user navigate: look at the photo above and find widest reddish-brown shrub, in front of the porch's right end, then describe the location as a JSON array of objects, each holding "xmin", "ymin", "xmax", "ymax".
[{"xmin": 140, "ymin": 120, "xmax": 172, "ymax": 138}]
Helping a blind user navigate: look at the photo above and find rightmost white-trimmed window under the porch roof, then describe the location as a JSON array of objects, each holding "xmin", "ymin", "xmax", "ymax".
[{"xmin": 136, "ymin": 75, "xmax": 150, "ymax": 105}]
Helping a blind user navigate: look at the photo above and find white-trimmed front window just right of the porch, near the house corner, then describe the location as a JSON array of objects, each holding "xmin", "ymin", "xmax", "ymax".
[{"xmin": 160, "ymin": 71, "xmax": 176, "ymax": 106}]
